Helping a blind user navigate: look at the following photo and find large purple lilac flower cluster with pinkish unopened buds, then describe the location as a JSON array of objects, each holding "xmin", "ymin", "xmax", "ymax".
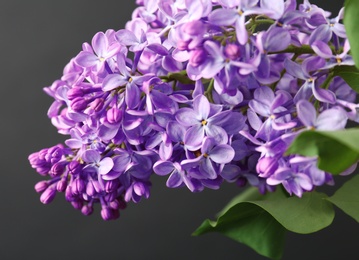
[{"xmin": 29, "ymin": 0, "xmax": 359, "ymax": 220}]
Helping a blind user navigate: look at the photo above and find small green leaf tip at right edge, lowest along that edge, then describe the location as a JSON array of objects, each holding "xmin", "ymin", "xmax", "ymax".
[{"xmin": 328, "ymin": 175, "xmax": 359, "ymax": 222}]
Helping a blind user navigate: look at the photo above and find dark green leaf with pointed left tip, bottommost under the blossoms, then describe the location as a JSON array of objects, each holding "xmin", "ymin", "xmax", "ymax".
[{"xmin": 192, "ymin": 187, "xmax": 286, "ymax": 259}]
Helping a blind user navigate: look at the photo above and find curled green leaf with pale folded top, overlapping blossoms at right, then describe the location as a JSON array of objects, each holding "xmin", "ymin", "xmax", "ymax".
[{"xmin": 286, "ymin": 128, "xmax": 359, "ymax": 174}]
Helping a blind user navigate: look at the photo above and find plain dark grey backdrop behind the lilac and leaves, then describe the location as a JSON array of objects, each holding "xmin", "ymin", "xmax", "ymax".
[{"xmin": 0, "ymin": 0, "xmax": 359, "ymax": 260}]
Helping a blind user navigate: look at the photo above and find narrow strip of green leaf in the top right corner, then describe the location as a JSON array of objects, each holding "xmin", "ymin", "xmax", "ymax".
[{"xmin": 344, "ymin": 0, "xmax": 359, "ymax": 68}]
